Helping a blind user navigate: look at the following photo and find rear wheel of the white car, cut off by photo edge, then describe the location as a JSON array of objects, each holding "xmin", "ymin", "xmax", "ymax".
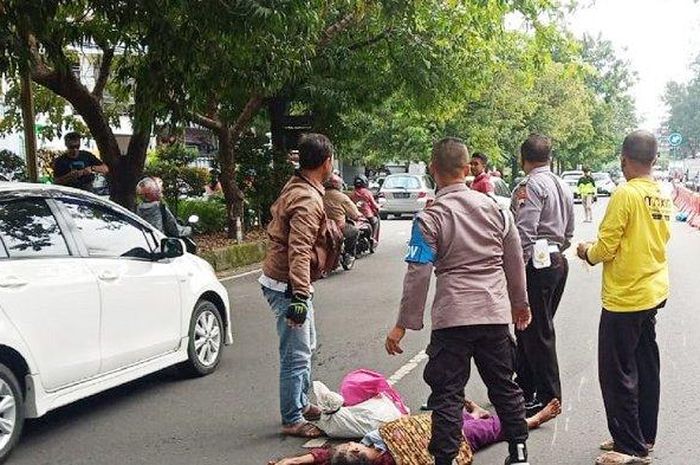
[{"xmin": 0, "ymin": 363, "xmax": 24, "ymax": 463}]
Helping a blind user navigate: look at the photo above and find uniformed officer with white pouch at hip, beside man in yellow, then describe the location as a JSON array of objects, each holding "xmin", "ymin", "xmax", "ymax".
[{"xmin": 512, "ymin": 134, "xmax": 574, "ymax": 414}]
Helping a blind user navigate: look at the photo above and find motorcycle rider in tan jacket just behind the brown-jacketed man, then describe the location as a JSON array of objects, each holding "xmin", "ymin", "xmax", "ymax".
[{"xmin": 323, "ymin": 174, "xmax": 362, "ymax": 259}]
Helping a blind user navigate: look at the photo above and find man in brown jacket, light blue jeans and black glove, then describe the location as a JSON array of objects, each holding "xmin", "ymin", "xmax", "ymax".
[{"xmin": 260, "ymin": 134, "xmax": 333, "ymax": 437}]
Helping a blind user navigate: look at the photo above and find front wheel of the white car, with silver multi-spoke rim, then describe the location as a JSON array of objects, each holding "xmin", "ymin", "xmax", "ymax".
[{"xmin": 183, "ymin": 300, "xmax": 224, "ymax": 376}]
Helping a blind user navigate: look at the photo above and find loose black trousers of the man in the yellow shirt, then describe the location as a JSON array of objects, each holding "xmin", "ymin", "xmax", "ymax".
[{"xmin": 598, "ymin": 302, "xmax": 666, "ymax": 457}]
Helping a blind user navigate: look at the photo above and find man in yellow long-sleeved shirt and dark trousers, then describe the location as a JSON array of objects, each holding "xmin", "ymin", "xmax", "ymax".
[{"xmin": 578, "ymin": 131, "xmax": 671, "ymax": 465}]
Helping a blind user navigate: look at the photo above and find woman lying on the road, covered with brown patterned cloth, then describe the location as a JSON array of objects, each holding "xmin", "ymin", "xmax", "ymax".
[{"xmin": 269, "ymin": 399, "xmax": 561, "ymax": 465}]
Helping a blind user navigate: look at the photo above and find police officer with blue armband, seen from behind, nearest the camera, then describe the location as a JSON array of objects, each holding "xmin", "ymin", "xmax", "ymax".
[{"xmin": 386, "ymin": 138, "xmax": 531, "ymax": 465}]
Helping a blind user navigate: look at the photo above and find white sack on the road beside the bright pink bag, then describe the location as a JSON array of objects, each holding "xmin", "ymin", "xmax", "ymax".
[{"xmin": 313, "ymin": 381, "xmax": 402, "ymax": 439}]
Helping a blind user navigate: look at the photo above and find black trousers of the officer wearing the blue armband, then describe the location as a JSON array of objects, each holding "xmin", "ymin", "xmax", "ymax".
[{"xmin": 423, "ymin": 325, "xmax": 528, "ymax": 465}]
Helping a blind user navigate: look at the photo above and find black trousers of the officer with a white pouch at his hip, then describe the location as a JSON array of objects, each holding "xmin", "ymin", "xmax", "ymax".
[{"xmin": 515, "ymin": 253, "xmax": 569, "ymax": 405}]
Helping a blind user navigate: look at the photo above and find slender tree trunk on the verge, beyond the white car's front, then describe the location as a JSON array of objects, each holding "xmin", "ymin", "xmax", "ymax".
[{"xmin": 217, "ymin": 129, "xmax": 245, "ymax": 241}]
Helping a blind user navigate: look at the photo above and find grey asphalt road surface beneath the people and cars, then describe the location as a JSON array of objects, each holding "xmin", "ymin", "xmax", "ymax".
[{"xmin": 9, "ymin": 196, "xmax": 700, "ymax": 465}]
